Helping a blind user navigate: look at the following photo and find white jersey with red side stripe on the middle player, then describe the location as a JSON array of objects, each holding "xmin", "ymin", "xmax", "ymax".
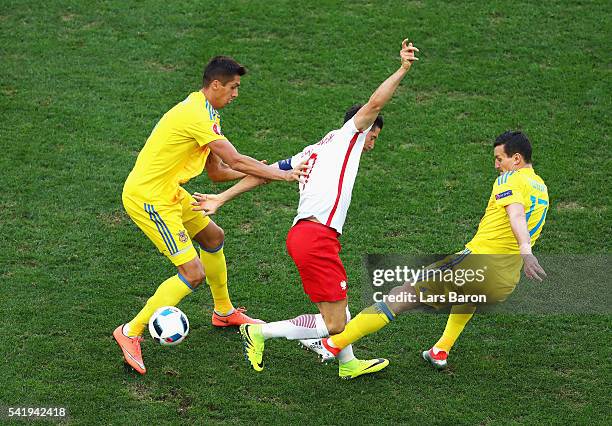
[{"xmin": 279, "ymin": 118, "xmax": 370, "ymax": 234}]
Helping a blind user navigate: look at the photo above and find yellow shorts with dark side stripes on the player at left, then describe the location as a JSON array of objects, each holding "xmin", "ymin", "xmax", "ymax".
[{"xmin": 122, "ymin": 188, "xmax": 210, "ymax": 266}]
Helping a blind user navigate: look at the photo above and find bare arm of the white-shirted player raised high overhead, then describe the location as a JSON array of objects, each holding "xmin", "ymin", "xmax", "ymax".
[{"xmin": 355, "ymin": 39, "xmax": 419, "ymax": 130}]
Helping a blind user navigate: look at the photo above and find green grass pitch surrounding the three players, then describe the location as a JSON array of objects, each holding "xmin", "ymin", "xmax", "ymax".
[{"xmin": 0, "ymin": 0, "xmax": 612, "ymax": 424}]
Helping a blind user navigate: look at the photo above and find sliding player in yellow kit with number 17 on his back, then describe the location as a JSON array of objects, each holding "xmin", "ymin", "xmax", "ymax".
[{"xmin": 322, "ymin": 131, "xmax": 549, "ymax": 369}]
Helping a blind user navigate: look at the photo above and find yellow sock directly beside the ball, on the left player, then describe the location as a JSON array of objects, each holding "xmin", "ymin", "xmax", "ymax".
[{"xmin": 127, "ymin": 274, "xmax": 192, "ymax": 337}]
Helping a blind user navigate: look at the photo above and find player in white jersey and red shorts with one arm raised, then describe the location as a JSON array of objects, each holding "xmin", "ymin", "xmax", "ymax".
[{"xmin": 194, "ymin": 40, "xmax": 418, "ymax": 379}]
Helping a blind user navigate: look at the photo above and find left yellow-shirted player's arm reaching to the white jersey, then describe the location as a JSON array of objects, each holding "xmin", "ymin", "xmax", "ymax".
[{"xmin": 208, "ymin": 139, "xmax": 306, "ymax": 182}]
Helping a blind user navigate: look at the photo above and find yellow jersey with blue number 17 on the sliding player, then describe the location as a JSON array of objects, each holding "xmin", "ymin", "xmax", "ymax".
[{"xmin": 466, "ymin": 167, "xmax": 549, "ymax": 254}]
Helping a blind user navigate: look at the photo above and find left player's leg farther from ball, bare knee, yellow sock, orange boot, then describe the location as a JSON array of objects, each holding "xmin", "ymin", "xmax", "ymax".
[{"xmin": 193, "ymin": 220, "xmax": 263, "ymax": 327}]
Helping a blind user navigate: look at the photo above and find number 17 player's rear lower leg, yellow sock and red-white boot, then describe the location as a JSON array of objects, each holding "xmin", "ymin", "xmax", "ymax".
[{"xmin": 422, "ymin": 305, "xmax": 476, "ymax": 370}]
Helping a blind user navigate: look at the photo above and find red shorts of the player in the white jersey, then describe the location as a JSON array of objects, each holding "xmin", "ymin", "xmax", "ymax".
[{"xmin": 287, "ymin": 220, "xmax": 347, "ymax": 303}]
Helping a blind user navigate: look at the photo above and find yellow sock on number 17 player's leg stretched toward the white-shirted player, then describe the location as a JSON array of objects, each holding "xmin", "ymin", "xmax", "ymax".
[{"xmin": 330, "ymin": 302, "xmax": 395, "ymax": 348}]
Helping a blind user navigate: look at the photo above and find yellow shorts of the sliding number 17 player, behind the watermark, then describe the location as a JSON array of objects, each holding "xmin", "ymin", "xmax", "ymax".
[{"xmin": 414, "ymin": 249, "xmax": 522, "ymax": 309}]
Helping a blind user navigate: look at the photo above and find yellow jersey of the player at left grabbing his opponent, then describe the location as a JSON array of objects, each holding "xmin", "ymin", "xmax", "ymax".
[{"xmin": 123, "ymin": 91, "xmax": 226, "ymax": 204}]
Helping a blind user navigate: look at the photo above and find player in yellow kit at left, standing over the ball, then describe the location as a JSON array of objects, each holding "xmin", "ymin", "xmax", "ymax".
[{"xmin": 113, "ymin": 56, "xmax": 304, "ymax": 374}]
